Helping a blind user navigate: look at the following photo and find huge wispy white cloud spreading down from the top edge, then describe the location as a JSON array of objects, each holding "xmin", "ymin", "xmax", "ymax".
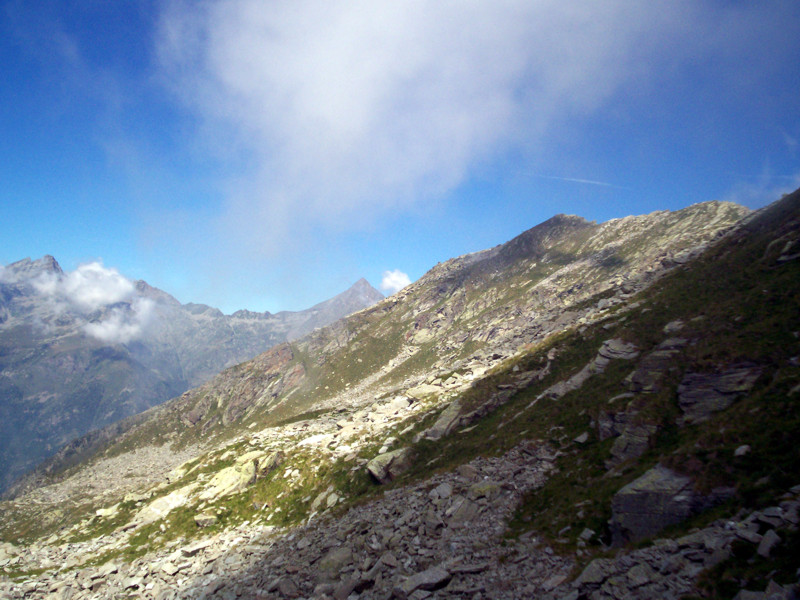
[{"xmin": 157, "ymin": 0, "xmax": 794, "ymax": 255}]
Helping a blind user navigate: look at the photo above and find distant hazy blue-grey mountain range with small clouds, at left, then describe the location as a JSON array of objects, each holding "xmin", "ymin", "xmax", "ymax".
[{"xmin": 0, "ymin": 264, "xmax": 383, "ymax": 490}]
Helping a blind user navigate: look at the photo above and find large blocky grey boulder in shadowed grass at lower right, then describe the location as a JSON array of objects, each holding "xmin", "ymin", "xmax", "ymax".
[{"xmin": 610, "ymin": 465, "xmax": 702, "ymax": 546}]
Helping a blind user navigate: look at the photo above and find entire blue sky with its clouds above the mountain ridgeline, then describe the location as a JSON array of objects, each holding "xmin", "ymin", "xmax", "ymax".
[{"xmin": 0, "ymin": 0, "xmax": 800, "ymax": 312}]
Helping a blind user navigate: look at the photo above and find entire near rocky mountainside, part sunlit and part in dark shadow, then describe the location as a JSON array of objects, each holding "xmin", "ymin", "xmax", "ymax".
[{"xmin": 0, "ymin": 191, "xmax": 800, "ymax": 599}]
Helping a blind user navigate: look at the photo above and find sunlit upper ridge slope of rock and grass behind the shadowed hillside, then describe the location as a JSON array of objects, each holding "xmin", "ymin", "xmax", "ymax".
[{"xmin": 20, "ymin": 202, "xmax": 747, "ymax": 470}]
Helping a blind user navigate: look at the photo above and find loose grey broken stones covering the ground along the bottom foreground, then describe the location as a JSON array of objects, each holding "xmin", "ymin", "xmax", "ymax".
[{"xmin": 6, "ymin": 442, "xmax": 800, "ymax": 600}]
